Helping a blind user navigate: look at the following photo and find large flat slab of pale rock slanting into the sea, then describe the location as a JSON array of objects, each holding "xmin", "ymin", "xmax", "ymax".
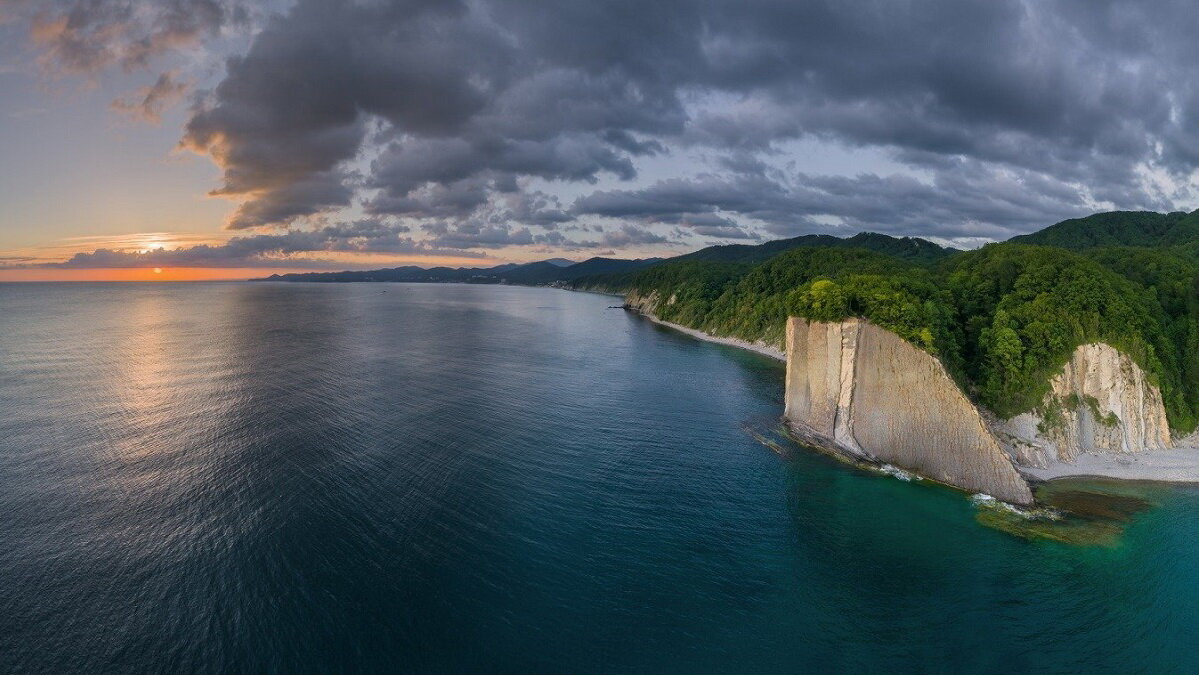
[{"xmin": 784, "ymin": 318, "xmax": 1032, "ymax": 505}]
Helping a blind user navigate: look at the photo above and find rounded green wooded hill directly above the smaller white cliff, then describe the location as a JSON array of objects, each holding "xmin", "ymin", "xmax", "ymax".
[{"xmin": 942, "ymin": 243, "xmax": 1199, "ymax": 430}]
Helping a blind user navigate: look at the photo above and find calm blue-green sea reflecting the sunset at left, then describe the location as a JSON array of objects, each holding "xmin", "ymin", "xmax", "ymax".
[{"xmin": 0, "ymin": 283, "xmax": 1199, "ymax": 673}]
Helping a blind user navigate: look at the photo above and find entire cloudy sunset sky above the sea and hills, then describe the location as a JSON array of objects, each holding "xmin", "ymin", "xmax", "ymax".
[{"xmin": 0, "ymin": 0, "xmax": 1199, "ymax": 281}]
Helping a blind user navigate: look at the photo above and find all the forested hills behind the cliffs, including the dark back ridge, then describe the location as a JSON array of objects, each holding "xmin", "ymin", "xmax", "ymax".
[{"xmin": 592, "ymin": 206, "xmax": 1199, "ymax": 442}]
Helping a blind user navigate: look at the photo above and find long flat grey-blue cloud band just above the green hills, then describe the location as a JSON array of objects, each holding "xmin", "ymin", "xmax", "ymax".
[{"xmin": 574, "ymin": 159, "xmax": 1085, "ymax": 239}]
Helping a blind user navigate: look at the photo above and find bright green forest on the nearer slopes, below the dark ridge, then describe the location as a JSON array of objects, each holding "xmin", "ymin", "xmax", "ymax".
[{"xmin": 609, "ymin": 243, "xmax": 1199, "ymax": 432}]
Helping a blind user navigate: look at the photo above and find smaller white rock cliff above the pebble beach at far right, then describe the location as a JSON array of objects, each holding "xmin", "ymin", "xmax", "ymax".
[{"xmin": 996, "ymin": 343, "xmax": 1170, "ymax": 468}]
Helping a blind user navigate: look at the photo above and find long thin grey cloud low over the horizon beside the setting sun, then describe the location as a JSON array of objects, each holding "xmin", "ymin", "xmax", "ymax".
[{"xmin": 37, "ymin": 219, "xmax": 481, "ymax": 269}]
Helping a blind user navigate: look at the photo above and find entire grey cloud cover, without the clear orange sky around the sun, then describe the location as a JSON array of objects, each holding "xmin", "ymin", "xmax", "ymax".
[{"xmin": 7, "ymin": 0, "xmax": 1199, "ymax": 263}]
